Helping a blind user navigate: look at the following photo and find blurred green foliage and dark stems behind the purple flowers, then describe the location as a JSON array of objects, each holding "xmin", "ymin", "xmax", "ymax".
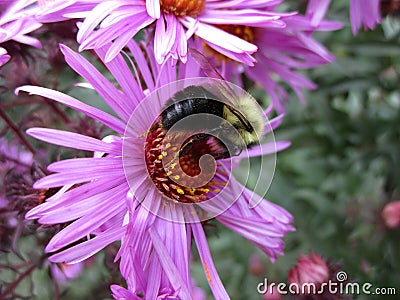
[{"xmin": 0, "ymin": 0, "xmax": 400, "ymax": 299}]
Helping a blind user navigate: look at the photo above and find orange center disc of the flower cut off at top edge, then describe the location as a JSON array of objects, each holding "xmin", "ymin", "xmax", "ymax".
[{"xmin": 160, "ymin": 0, "xmax": 205, "ymax": 17}]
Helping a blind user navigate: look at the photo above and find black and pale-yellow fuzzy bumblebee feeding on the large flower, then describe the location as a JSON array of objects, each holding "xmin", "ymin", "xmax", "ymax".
[{"xmin": 150, "ymin": 49, "xmax": 264, "ymax": 163}]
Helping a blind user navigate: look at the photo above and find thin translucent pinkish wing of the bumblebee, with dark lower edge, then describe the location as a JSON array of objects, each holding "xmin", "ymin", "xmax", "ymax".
[{"xmin": 189, "ymin": 48, "xmax": 252, "ymax": 130}]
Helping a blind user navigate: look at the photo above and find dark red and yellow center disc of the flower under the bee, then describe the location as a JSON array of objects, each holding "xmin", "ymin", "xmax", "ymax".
[{"xmin": 145, "ymin": 124, "xmax": 221, "ymax": 203}]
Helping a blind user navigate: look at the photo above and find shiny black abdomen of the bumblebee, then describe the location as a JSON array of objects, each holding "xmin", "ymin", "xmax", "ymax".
[{"xmin": 161, "ymin": 86, "xmax": 224, "ymax": 130}]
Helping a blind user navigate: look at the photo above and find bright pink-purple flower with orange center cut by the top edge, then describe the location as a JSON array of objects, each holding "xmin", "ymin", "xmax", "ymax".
[{"xmin": 35, "ymin": 0, "xmax": 288, "ymax": 65}]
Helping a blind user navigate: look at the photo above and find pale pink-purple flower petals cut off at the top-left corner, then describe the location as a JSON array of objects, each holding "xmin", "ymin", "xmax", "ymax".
[{"xmin": 0, "ymin": 0, "xmax": 42, "ymax": 67}]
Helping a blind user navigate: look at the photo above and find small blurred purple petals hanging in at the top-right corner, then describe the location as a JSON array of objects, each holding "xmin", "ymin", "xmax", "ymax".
[{"xmin": 350, "ymin": 0, "xmax": 381, "ymax": 35}]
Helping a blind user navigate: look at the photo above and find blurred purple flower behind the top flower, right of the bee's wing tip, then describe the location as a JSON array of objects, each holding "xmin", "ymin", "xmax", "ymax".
[{"xmin": 198, "ymin": 0, "xmax": 342, "ymax": 113}]
